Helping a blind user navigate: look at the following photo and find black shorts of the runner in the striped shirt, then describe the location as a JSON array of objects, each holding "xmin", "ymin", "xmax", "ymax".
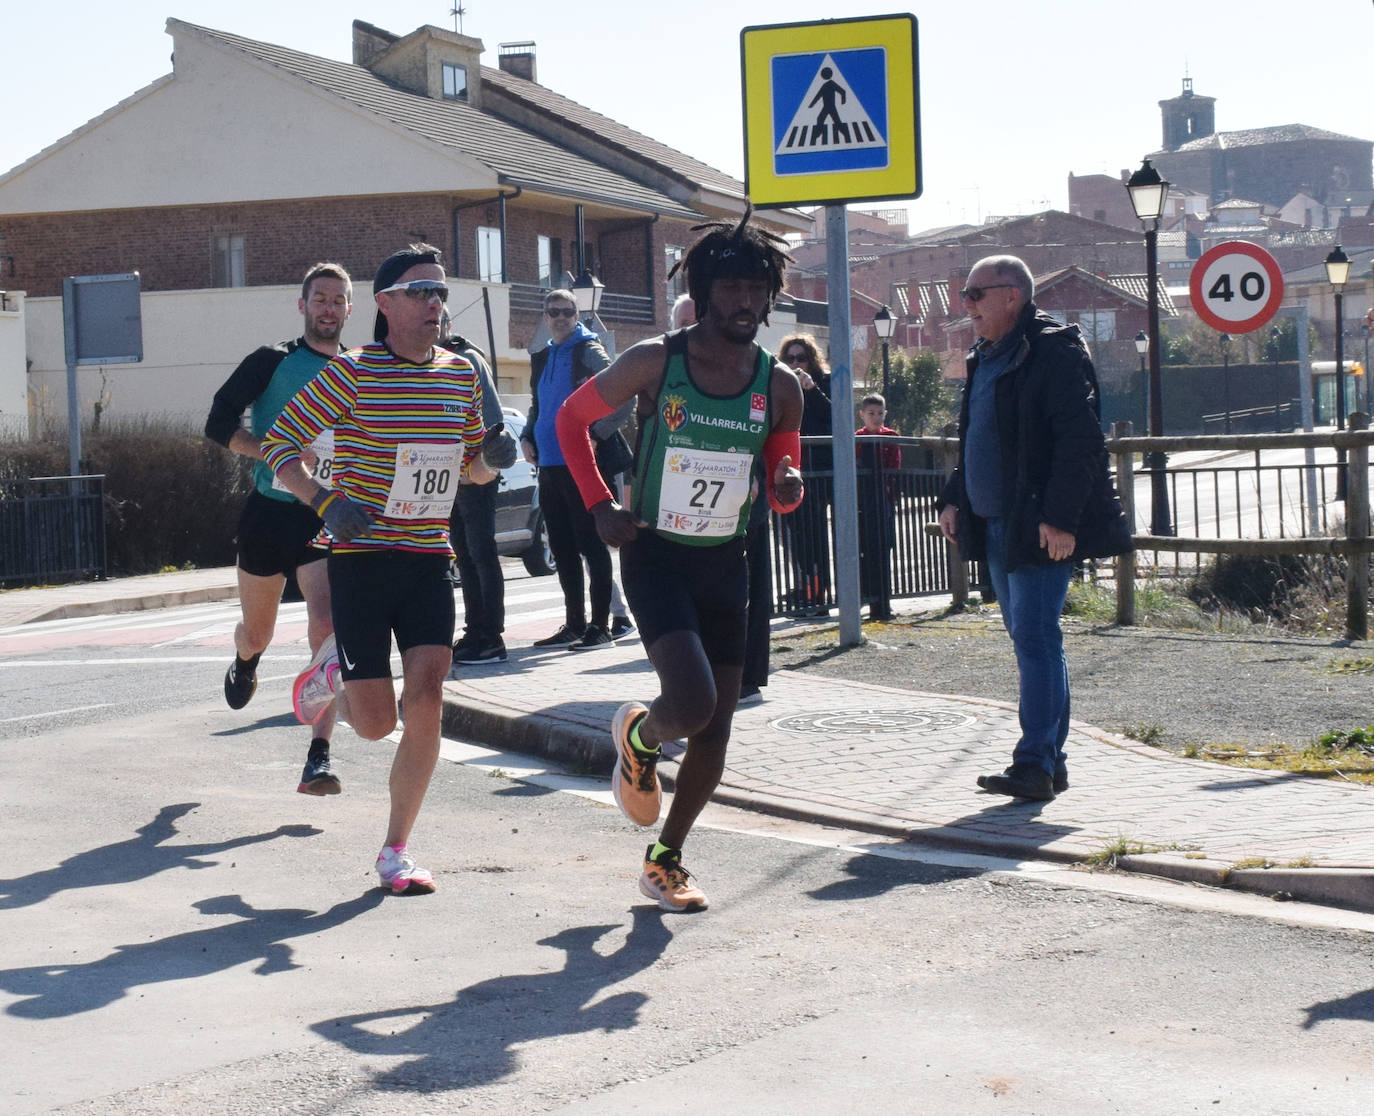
[{"xmin": 330, "ymin": 550, "xmax": 455, "ymax": 682}]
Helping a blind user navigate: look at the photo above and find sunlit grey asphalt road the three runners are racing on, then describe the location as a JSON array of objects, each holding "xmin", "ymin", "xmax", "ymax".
[{"xmin": 0, "ymin": 617, "xmax": 1374, "ymax": 1116}]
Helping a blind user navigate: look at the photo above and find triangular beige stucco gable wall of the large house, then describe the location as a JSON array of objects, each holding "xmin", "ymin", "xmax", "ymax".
[{"xmin": 0, "ymin": 26, "xmax": 496, "ymax": 214}]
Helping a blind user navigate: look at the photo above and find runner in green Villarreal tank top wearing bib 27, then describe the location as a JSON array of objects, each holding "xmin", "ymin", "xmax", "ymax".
[{"xmin": 558, "ymin": 214, "xmax": 802, "ymax": 911}]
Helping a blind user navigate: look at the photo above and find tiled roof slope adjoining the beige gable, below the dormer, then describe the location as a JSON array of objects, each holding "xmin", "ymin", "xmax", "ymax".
[{"xmin": 177, "ymin": 19, "xmax": 699, "ymax": 217}]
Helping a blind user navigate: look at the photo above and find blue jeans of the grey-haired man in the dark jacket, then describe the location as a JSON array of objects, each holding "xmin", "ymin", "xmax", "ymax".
[{"xmin": 987, "ymin": 518, "xmax": 1073, "ymax": 775}]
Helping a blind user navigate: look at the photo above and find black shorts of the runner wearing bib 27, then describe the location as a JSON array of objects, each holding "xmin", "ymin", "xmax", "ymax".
[{"xmin": 620, "ymin": 528, "xmax": 749, "ymax": 667}]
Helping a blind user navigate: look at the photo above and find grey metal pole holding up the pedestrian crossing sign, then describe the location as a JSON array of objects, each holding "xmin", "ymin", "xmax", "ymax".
[{"xmin": 826, "ymin": 205, "xmax": 863, "ymax": 647}]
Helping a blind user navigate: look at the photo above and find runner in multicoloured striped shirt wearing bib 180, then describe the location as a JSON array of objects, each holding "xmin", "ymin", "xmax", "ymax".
[{"xmin": 264, "ymin": 245, "xmax": 497, "ymax": 895}]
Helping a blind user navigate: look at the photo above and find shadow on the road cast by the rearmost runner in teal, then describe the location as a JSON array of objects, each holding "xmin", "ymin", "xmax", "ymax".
[{"xmin": 0, "ymin": 803, "xmax": 323, "ymax": 910}]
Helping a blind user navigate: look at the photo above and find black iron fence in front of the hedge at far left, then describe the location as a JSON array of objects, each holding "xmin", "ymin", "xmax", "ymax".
[{"xmin": 0, "ymin": 477, "xmax": 106, "ymax": 588}]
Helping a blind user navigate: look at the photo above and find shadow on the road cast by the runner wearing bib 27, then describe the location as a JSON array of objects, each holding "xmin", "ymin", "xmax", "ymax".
[{"xmin": 313, "ymin": 907, "xmax": 672, "ymax": 1090}]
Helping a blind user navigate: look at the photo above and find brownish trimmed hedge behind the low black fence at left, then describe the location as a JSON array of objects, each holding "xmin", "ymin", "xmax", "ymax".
[{"xmin": 0, "ymin": 418, "xmax": 253, "ymax": 574}]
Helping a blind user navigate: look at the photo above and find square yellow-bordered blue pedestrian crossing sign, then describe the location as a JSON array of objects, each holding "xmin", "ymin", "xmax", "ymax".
[{"xmin": 739, "ymin": 14, "xmax": 921, "ymax": 208}]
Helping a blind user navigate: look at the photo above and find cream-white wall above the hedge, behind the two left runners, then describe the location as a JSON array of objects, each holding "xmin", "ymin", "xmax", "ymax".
[{"xmin": 25, "ymin": 279, "xmax": 529, "ymax": 429}]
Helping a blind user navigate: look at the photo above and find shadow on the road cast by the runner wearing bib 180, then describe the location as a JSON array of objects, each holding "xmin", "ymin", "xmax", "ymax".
[{"xmin": 0, "ymin": 888, "xmax": 385, "ymax": 1020}]
